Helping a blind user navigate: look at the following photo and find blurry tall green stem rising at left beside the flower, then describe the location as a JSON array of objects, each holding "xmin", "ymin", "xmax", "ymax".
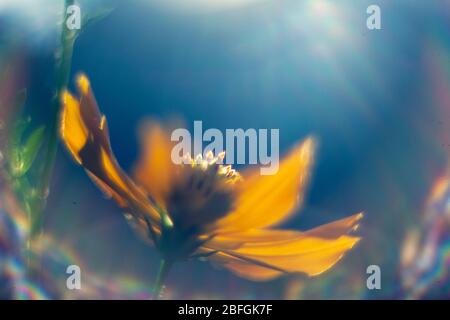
[{"xmin": 30, "ymin": 0, "xmax": 78, "ymax": 238}]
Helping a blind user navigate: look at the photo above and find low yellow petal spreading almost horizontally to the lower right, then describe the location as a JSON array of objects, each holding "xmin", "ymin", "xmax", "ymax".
[{"xmin": 206, "ymin": 214, "xmax": 362, "ymax": 281}]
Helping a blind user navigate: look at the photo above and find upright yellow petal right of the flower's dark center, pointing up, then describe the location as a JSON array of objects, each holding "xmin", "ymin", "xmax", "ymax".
[{"xmin": 216, "ymin": 138, "xmax": 315, "ymax": 233}]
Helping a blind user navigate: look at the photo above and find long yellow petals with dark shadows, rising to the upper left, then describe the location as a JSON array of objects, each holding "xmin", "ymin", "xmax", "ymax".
[{"xmin": 60, "ymin": 75, "xmax": 159, "ymax": 222}]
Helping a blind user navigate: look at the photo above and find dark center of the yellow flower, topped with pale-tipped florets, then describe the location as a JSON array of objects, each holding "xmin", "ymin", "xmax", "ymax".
[{"xmin": 148, "ymin": 152, "xmax": 241, "ymax": 261}]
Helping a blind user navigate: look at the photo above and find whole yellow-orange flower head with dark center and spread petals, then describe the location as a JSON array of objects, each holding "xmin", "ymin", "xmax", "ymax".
[{"xmin": 60, "ymin": 75, "xmax": 362, "ymax": 280}]
